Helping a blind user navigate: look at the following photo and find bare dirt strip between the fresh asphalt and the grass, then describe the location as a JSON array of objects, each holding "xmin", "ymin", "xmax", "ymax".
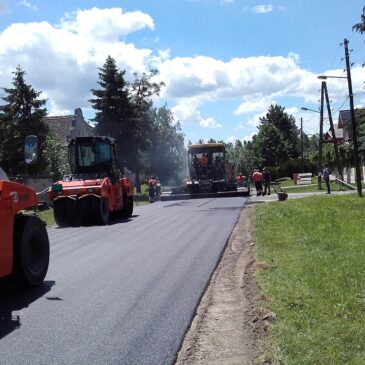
[{"xmin": 176, "ymin": 207, "xmax": 271, "ymax": 365}]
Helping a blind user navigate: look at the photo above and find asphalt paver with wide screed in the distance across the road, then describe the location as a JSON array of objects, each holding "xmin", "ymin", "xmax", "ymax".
[{"xmin": 161, "ymin": 143, "xmax": 250, "ymax": 200}]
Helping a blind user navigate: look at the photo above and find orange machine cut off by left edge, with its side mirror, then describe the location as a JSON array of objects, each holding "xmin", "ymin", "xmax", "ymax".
[{"xmin": 0, "ymin": 136, "xmax": 49, "ymax": 288}]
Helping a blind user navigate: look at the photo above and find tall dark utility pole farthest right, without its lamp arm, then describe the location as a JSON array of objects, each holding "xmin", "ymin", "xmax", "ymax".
[{"xmin": 343, "ymin": 38, "xmax": 362, "ymax": 196}]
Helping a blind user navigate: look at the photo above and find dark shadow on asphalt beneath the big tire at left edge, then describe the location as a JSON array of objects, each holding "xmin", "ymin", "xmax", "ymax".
[{"xmin": 0, "ymin": 280, "xmax": 55, "ymax": 339}]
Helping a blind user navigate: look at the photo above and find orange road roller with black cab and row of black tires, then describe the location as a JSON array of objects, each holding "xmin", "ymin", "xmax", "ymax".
[{"xmin": 47, "ymin": 137, "xmax": 134, "ymax": 227}]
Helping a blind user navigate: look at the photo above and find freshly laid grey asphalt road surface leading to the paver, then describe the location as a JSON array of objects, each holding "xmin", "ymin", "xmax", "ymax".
[{"xmin": 0, "ymin": 197, "xmax": 247, "ymax": 365}]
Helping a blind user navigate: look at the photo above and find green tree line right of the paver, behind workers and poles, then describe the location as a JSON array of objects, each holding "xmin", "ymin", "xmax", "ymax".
[{"xmin": 203, "ymin": 105, "xmax": 365, "ymax": 179}]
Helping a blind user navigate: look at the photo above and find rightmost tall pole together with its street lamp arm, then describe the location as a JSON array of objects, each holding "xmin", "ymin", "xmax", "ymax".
[{"xmin": 318, "ymin": 71, "xmax": 362, "ymax": 197}]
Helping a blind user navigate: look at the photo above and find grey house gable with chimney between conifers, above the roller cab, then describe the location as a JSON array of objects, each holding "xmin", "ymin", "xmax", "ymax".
[{"xmin": 43, "ymin": 108, "xmax": 94, "ymax": 147}]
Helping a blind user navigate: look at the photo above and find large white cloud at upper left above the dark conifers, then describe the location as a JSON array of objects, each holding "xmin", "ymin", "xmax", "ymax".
[{"xmin": 0, "ymin": 8, "xmax": 155, "ymax": 113}]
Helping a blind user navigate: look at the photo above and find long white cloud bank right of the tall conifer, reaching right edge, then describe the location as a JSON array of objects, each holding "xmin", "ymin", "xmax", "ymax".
[{"xmin": 159, "ymin": 50, "xmax": 365, "ymax": 115}]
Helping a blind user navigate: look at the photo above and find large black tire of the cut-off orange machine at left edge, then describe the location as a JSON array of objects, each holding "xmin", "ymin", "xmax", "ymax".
[{"xmin": 9, "ymin": 215, "xmax": 49, "ymax": 289}]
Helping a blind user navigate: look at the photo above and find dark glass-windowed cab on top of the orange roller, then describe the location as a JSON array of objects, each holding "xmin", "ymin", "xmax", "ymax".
[{"xmin": 68, "ymin": 137, "xmax": 118, "ymax": 181}]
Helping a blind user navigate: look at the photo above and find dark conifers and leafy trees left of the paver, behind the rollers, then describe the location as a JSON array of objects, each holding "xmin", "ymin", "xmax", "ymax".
[{"xmin": 0, "ymin": 56, "xmax": 186, "ymax": 191}]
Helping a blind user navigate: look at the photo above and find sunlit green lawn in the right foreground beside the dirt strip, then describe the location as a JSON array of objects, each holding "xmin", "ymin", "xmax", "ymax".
[{"xmin": 253, "ymin": 194, "xmax": 365, "ymax": 365}]
